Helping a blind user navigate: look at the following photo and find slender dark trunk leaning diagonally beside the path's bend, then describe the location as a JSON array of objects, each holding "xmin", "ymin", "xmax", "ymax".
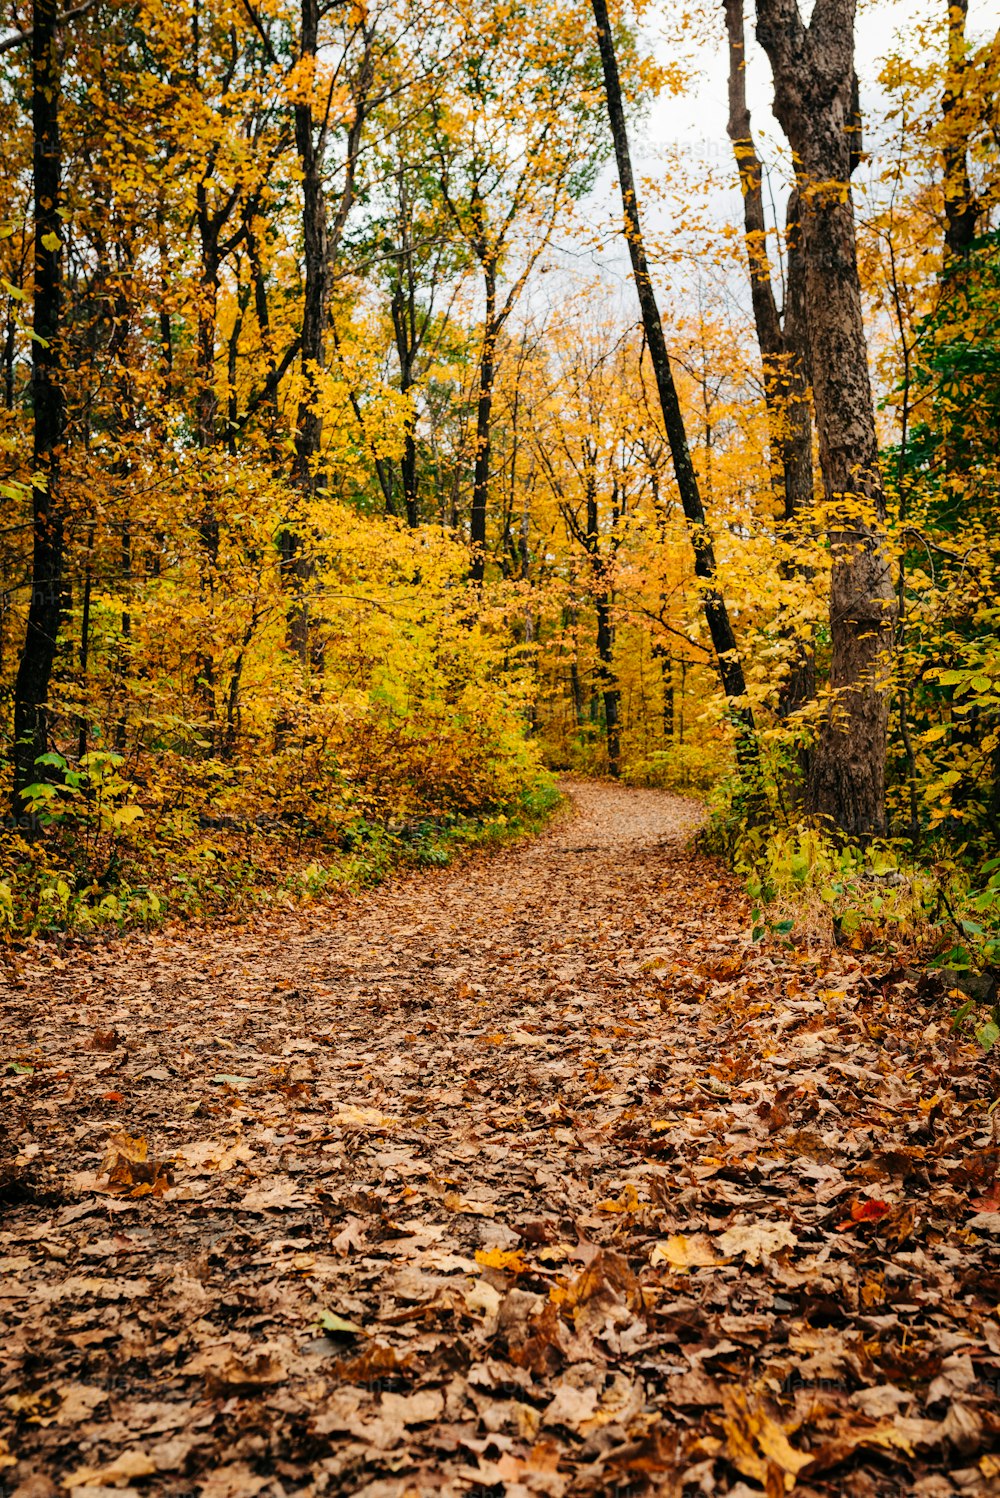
[{"xmin": 591, "ymin": 0, "xmax": 757, "ymax": 764}]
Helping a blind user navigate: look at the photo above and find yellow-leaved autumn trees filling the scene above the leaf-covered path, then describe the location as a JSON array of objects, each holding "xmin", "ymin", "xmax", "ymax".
[{"xmin": 0, "ymin": 0, "xmax": 1000, "ymax": 926}]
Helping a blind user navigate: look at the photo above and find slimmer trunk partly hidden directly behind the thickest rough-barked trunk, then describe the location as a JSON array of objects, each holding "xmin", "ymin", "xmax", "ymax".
[{"xmin": 725, "ymin": 0, "xmax": 816, "ymax": 718}]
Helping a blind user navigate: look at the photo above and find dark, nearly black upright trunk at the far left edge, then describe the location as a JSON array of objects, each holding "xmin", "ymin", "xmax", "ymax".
[{"xmin": 13, "ymin": 0, "xmax": 66, "ymax": 815}]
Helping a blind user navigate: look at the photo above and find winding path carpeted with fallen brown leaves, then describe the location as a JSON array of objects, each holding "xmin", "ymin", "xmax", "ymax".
[{"xmin": 0, "ymin": 783, "xmax": 1000, "ymax": 1498}]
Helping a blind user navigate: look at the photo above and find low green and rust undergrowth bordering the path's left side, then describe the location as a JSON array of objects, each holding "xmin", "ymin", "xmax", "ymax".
[{"xmin": 0, "ymin": 756, "xmax": 561, "ymax": 944}]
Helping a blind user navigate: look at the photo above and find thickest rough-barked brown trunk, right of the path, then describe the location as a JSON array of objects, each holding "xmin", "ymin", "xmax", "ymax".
[{"xmin": 757, "ymin": 0, "xmax": 895, "ymax": 839}]
